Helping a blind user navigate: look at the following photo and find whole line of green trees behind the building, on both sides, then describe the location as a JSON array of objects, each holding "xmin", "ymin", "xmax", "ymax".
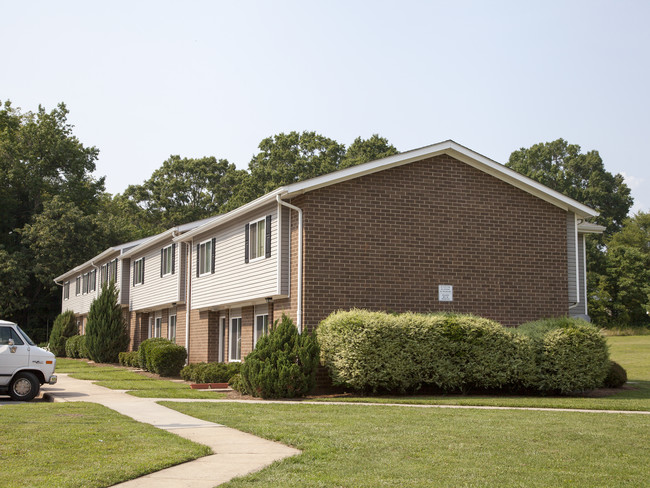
[{"xmin": 0, "ymin": 101, "xmax": 650, "ymax": 340}]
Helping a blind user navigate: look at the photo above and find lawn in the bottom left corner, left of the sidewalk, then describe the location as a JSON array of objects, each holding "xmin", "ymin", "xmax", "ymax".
[{"xmin": 0, "ymin": 402, "xmax": 210, "ymax": 488}]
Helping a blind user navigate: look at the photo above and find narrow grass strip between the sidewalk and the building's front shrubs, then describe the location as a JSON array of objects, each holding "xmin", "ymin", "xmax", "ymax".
[{"xmin": 56, "ymin": 358, "xmax": 226, "ymax": 399}]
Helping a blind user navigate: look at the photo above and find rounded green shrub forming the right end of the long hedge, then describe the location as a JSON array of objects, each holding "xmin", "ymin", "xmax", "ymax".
[{"xmin": 517, "ymin": 317, "xmax": 610, "ymax": 394}]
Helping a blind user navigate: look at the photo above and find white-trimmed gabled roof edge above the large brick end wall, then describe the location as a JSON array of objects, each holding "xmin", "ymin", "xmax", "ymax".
[{"xmin": 174, "ymin": 139, "xmax": 598, "ymax": 241}]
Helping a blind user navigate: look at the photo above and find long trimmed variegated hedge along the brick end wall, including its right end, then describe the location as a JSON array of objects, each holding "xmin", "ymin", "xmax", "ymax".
[{"xmin": 317, "ymin": 310, "xmax": 609, "ymax": 394}]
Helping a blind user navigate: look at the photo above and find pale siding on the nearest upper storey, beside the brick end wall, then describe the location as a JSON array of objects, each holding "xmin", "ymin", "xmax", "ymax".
[{"xmin": 191, "ymin": 205, "xmax": 278, "ymax": 309}]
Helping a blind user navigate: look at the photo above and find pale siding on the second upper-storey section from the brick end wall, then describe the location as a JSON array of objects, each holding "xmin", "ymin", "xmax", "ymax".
[{"xmin": 128, "ymin": 237, "xmax": 185, "ymax": 311}]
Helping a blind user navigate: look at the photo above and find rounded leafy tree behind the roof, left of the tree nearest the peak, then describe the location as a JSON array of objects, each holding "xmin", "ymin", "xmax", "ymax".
[{"xmin": 121, "ymin": 156, "xmax": 246, "ymax": 231}]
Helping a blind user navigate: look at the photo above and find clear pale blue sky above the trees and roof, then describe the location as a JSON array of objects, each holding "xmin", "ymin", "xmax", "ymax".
[{"xmin": 0, "ymin": 0, "xmax": 650, "ymax": 211}]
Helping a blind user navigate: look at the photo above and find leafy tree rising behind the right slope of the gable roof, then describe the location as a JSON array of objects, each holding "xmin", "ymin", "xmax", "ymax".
[{"xmin": 506, "ymin": 139, "xmax": 633, "ymax": 236}]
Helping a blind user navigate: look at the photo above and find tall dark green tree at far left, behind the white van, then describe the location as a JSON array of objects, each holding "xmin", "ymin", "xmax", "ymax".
[{"xmin": 0, "ymin": 101, "xmax": 104, "ymax": 341}]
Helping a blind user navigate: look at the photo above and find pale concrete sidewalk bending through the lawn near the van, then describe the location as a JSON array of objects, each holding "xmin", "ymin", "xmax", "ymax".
[{"xmin": 43, "ymin": 374, "xmax": 301, "ymax": 488}]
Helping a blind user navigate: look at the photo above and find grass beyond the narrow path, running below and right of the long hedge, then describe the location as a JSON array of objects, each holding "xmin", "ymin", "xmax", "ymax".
[{"xmin": 308, "ymin": 335, "xmax": 650, "ymax": 411}]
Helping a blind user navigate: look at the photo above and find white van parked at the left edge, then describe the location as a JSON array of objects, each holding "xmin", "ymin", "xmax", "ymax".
[{"xmin": 0, "ymin": 320, "xmax": 56, "ymax": 402}]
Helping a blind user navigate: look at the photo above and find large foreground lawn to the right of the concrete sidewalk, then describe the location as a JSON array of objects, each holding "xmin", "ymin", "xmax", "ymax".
[{"xmin": 162, "ymin": 402, "xmax": 650, "ymax": 488}]
